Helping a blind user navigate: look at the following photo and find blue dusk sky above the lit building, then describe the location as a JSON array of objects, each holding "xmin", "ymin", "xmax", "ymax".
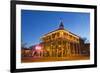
[{"xmin": 21, "ymin": 10, "xmax": 90, "ymax": 47}]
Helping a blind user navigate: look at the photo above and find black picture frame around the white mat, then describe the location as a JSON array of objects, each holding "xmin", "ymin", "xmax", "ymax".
[{"xmin": 10, "ymin": 1, "xmax": 97, "ymax": 72}]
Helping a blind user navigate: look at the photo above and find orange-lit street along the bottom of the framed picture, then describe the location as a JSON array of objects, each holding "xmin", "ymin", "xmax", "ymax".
[{"xmin": 22, "ymin": 56, "xmax": 89, "ymax": 63}]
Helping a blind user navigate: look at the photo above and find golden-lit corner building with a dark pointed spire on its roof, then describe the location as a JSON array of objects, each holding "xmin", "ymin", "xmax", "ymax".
[{"xmin": 41, "ymin": 22, "xmax": 84, "ymax": 58}]
